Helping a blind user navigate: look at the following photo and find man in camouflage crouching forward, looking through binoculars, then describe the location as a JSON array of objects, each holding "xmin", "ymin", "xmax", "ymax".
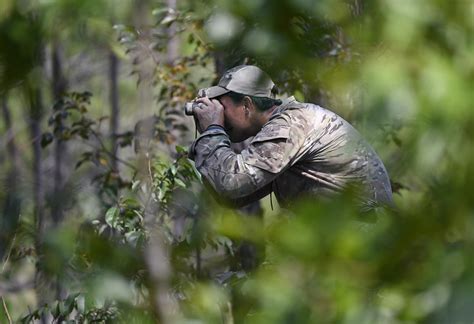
[{"xmin": 190, "ymin": 65, "xmax": 392, "ymax": 208}]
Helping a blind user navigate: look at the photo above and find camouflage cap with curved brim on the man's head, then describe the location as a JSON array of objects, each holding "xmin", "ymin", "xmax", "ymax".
[{"xmin": 204, "ymin": 65, "xmax": 275, "ymax": 98}]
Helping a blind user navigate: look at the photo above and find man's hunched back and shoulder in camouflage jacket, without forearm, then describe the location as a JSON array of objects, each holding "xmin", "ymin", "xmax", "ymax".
[{"xmin": 242, "ymin": 98, "xmax": 392, "ymax": 206}]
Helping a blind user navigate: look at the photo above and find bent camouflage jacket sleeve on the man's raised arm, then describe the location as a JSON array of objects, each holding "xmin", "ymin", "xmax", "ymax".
[{"xmin": 190, "ymin": 116, "xmax": 297, "ymax": 203}]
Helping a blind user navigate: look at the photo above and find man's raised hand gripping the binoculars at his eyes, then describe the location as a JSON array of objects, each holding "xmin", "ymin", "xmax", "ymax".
[{"xmin": 194, "ymin": 97, "xmax": 224, "ymax": 133}]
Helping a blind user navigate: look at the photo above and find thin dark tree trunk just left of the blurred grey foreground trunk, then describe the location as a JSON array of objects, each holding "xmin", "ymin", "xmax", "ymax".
[{"xmin": 109, "ymin": 51, "xmax": 120, "ymax": 171}]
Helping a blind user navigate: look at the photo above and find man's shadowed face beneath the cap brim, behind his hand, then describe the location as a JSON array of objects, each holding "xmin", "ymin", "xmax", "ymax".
[{"xmin": 219, "ymin": 95, "xmax": 255, "ymax": 143}]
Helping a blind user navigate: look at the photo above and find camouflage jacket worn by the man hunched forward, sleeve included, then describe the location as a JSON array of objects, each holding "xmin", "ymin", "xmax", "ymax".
[{"xmin": 190, "ymin": 97, "xmax": 392, "ymax": 207}]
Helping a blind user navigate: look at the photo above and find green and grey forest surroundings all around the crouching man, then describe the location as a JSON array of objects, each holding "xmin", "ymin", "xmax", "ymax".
[{"xmin": 0, "ymin": 0, "xmax": 474, "ymax": 323}]
